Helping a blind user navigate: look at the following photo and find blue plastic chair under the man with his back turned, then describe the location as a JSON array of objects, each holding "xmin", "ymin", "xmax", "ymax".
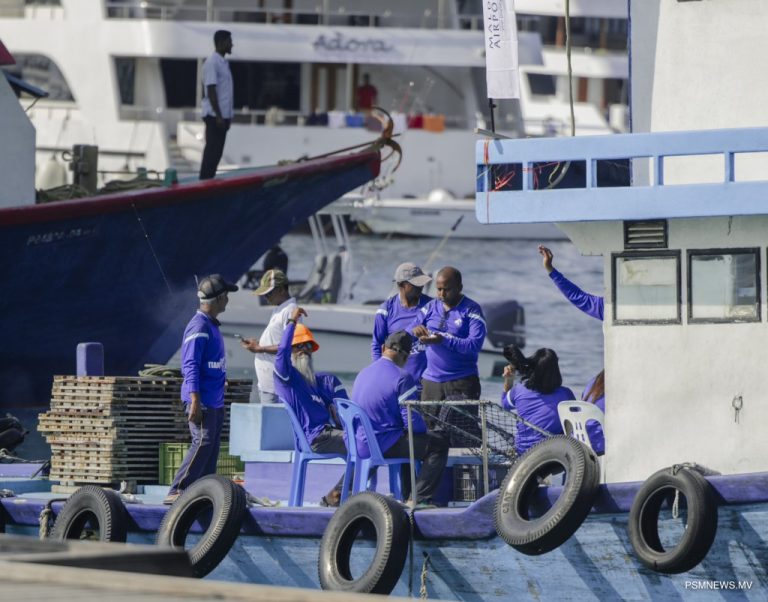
[{"xmin": 333, "ymin": 398, "xmax": 420, "ymax": 503}]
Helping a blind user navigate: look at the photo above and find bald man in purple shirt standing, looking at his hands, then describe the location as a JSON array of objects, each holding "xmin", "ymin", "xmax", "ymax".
[{"xmin": 407, "ymin": 266, "xmax": 486, "ymax": 447}]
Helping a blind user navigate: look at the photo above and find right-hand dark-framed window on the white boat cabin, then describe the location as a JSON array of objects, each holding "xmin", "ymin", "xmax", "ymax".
[{"xmin": 688, "ymin": 249, "xmax": 760, "ymax": 323}]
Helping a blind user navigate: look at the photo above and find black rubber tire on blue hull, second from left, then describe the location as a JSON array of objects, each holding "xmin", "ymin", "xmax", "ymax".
[{"xmin": 155, "ymin": 475, "xmax": 247, "ymax": 577}]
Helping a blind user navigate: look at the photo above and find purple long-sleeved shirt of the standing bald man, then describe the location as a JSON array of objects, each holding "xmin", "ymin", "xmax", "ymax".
[{"xmin": 406, "ymin": 297, "xmax": 486, "ymax": 383}]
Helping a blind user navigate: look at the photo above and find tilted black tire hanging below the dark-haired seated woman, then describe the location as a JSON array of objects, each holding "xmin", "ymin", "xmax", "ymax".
[{"xmin": 493, "ymin": 435, "xmax": 600, "ymax": 556}]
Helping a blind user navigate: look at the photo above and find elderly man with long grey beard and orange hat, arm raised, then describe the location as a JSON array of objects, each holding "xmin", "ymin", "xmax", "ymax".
[{"xmin": 275, "ymin": 307, "xmax": 349, "ymax": 506}]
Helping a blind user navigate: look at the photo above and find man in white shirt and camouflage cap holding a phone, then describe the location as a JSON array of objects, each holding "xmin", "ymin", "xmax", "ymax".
[{"xmin": 240, "ymin": 269, "xmax": 296, "ymax": 403}]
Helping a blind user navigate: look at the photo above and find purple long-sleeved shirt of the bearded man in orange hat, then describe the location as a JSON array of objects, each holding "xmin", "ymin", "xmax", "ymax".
[{"xmin": 275, "ymin": 322, "xmax": 349, "ymax": 444}]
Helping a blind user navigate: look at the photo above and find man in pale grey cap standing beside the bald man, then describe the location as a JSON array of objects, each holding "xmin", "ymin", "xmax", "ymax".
[{"xmin": 371, "ymin": 263, "xmax": 432, "ymax": 390}]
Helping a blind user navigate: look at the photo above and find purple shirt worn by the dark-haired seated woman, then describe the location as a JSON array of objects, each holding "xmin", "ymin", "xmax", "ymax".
[{"xmin": 501, "ymin": 383, "xmax": 576, "ymax": 454}]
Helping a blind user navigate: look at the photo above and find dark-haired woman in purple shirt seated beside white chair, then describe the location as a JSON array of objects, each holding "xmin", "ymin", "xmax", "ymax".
[{"xmin": 501, "ymin": 345, "xmax": 576, "ymax": 454}]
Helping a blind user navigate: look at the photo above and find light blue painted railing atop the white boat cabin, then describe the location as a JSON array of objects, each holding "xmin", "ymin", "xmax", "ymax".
[{"xmin": 476, "ymin": 128, "xmax": 768, "ymax": 224}]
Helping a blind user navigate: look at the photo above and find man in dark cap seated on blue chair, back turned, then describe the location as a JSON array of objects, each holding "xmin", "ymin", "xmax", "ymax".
[{"xmin": 352, "ymin": 330, "xmax": 448, "ymax": 504}]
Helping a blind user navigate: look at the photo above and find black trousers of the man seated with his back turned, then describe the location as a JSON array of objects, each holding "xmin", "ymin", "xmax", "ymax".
[{"xmin": 384, "ymin": 432, "xmax": 448, "ymax": 502}]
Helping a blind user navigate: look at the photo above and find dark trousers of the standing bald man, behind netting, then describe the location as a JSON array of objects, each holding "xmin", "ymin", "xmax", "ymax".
[{"xmin": 421, "ymin": 375, "xmax": 481, "ymax": 447}]
